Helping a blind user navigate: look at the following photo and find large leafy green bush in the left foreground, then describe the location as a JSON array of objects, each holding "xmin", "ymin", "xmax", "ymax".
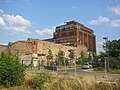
[{"xmin": 0, "ymin": 53, "xmax": 25, "ymax": 87}]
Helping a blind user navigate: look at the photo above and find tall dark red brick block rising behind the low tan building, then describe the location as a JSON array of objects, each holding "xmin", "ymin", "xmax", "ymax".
[{"xmin": 53, "ymin": 21, "xmax": 96, "ymax": 52}]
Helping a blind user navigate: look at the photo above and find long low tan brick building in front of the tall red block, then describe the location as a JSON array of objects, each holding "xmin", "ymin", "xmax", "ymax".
[{"xmin": 0, "ymin": 38, "xmax": 87, "ymax": 66}]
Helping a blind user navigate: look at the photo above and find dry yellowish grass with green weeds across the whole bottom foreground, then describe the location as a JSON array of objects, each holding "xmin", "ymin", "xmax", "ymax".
[{"xmin": 0, "ymin": 72, "xmax": 120, "ymax": 90}]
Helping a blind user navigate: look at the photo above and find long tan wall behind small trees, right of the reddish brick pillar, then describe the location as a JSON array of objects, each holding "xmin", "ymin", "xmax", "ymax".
[{"xmin": 38, "ymin": 41, "xmax": 87, "ymax": 58}]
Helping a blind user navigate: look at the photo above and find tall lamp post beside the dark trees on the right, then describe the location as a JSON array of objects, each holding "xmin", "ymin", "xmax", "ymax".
[{"xmin": 103, "ymin": 37, "xmax": 109, "ymax": 70}]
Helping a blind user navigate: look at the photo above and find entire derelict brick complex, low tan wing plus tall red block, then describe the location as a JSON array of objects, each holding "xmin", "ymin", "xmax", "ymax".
[{"xmin": 0, "ymin": 21, "xmax": 96, "ymax": 66}]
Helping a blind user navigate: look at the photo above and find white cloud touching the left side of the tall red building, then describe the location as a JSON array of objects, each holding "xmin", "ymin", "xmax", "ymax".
[{"xmin": 35, "ymin": 28, "xmax": 54, "ymax": 36}]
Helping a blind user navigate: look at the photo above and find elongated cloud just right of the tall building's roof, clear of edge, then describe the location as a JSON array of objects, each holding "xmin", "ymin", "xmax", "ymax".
[{"xmin": 88, "ymin": 16, "xmax": 110, "ymax": 25}]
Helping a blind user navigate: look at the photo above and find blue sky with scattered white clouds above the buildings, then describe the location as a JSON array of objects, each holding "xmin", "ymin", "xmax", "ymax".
[{"xmin": 0, "ymin": 0, "xmax": 120, "ymax": 52}]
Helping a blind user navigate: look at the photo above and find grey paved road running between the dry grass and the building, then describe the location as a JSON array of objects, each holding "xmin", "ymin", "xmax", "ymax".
[{"xmin": 28, "ymin": 68, "xmax": 120, "ymax": 78}]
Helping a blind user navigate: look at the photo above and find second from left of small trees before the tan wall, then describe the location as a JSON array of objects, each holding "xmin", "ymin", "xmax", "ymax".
[{"xmin": 56, "ymin": 50, "xmax": 65, "ymax": 66}]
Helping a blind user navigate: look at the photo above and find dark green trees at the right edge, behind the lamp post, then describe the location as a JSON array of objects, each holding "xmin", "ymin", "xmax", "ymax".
[{"xmin": 94, "ymin": 39, "xmax": 120, "ymax": 71}]
